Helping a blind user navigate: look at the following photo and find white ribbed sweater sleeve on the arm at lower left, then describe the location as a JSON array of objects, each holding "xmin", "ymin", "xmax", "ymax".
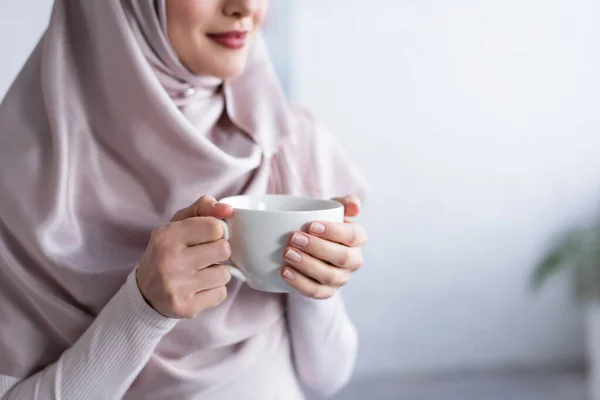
[{"xmin": 0, "ymin": 270, "xmax": 178, "ymax": 400}]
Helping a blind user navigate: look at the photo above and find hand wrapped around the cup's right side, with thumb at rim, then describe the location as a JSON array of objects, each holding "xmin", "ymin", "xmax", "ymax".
[{"xmin": 281, "ymin": 195, "xmax": 367, "ymax": 299}]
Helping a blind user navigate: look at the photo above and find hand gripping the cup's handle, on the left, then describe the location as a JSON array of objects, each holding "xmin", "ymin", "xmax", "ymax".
[{"xmin": 137, "ymin": 196, "xmax": 233, "ymax": 319}]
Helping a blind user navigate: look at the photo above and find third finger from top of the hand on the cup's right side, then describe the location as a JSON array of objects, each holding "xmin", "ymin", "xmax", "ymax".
[{"xmin": 285, "ymin": 248, "xmax": 351, "ymax": 287}]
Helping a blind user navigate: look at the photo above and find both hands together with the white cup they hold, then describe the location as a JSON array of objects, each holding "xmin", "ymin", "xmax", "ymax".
[{"xmin": 137, "ymin": 195, "xmax": 367, "ymax": 319}]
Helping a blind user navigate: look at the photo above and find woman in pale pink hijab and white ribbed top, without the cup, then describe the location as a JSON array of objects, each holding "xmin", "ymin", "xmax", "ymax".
[{"xmin": 0, "ymin": 0, "xmax": 366, "ymax": 400}]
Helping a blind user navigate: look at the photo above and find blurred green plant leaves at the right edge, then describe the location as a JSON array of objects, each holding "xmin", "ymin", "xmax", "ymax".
[{"xmin": 531, "ymin": 226, "xmax": 600, "ymax": 301}]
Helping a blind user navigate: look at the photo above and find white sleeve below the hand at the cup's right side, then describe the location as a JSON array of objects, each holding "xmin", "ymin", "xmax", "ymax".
[{"xmin": 287, "ymin": 292, "xmax": 358, "ymax": 397}]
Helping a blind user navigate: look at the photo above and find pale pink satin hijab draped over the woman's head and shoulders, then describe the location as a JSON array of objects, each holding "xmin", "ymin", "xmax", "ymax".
[{"xmin": 0, "ymin": 0, "xmax": 362, "ymax": 377}]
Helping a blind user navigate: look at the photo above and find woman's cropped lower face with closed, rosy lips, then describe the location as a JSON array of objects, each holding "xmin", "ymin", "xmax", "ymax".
[{"xmin": 166, "ymin": 0, "xmax": 268, "ymax": 80}]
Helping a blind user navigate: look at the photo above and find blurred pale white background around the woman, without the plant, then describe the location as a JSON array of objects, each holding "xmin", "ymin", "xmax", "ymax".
[{"xmin": 0, "ymin": 0, "xmax": 600, "ymax": 400}]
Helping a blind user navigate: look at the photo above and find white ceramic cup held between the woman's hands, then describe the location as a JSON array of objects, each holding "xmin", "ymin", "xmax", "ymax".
[{"xmin": 220, "ymin": 195, "xmax": 344, "ymax": 293}]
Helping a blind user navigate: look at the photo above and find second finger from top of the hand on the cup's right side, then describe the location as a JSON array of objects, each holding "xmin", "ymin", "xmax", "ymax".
[{"xmin": 290, "ymin": 232, "xmax": 363, "ymax": 271}]
